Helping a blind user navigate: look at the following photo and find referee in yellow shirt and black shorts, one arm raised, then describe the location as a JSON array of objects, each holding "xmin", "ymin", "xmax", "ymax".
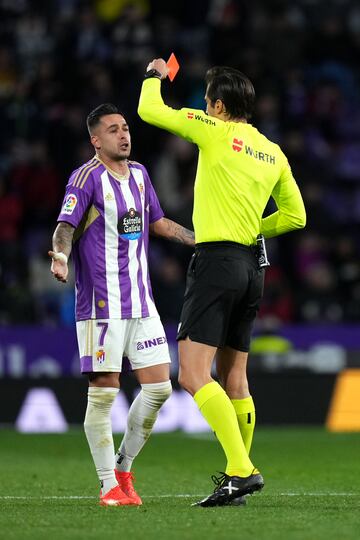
[{"xmin": 138, "ymin": 59, "xmax": 306, "ymax": 506}]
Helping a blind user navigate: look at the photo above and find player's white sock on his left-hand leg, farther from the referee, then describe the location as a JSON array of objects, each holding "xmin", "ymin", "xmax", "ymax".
[{"xmin": 84, "ymin": 386, "xmax": 119, "ymax": 495}]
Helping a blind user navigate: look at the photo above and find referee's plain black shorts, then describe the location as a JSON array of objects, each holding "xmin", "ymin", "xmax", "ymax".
[{"xmin": 176, "ymin": 242, "xmax": 264, "ymax": 352}]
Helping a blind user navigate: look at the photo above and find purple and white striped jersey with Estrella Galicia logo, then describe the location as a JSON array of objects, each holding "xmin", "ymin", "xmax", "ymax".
[{"xmin": 58, "ymin": 156, "xmax": 164, "ymax": 321}]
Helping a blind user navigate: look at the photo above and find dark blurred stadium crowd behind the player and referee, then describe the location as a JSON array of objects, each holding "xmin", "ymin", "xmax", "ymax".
[{"xmin": 0, "ymin": 0, "xmax": 360, "ymax": 326}]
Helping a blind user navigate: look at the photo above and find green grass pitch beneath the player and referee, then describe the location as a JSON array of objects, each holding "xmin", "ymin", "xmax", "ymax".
[{"xmin": 0, "ymin": 428, "xmax": 360, "ymax": 540}]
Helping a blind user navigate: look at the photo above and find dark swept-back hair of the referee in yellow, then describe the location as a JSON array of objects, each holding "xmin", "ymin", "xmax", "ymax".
[{"xmin": 205, "ymin": 66, "xmax": 255, "ymax": 120}]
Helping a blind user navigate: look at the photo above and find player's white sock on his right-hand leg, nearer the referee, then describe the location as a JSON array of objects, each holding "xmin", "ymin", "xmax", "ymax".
[{"xmin": 115, "ymin": 381, "xmax": 172, "ymax": 472}]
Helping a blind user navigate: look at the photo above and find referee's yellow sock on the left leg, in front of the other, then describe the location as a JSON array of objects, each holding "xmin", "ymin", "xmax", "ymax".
[{"xmin": 194, "ymin": 382, "xmax": 254, "ymax": 477}]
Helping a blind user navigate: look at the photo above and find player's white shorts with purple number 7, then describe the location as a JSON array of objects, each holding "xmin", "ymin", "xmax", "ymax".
[{"xmin": 76, "ymin": 316, "xmax": 170, "ymax": 373}]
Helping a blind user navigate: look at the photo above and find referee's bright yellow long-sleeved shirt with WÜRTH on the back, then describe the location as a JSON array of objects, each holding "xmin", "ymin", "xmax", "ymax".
[{"xmin": 138, "ymin": 78, "xmax": 306, "ymax": 245}]
